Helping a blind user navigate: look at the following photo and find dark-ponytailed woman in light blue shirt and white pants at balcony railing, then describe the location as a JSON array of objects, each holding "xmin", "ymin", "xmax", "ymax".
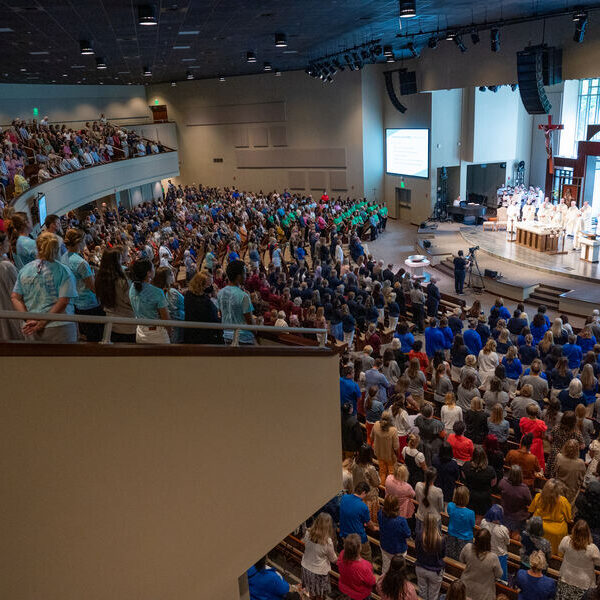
[{"xmin": 129, "ymin": 258, "xmax": 170, "ymax": 344}]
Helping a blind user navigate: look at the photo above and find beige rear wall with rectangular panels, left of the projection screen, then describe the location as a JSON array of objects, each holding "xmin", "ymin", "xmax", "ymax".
[{"xmin": 147, "ymin": 71, "xmax": 364, "ymax": 197}]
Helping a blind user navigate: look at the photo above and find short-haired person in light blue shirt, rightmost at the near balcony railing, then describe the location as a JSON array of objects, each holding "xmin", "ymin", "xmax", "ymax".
[{"xmin": 217, "ymin": 260, "xmax": 254, "ymax": 344}]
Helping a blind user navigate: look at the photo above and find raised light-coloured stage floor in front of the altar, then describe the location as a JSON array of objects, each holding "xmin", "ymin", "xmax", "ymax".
[{"xmin": 460, "ymin": 225, "xmax": 600, "ymax": 282}]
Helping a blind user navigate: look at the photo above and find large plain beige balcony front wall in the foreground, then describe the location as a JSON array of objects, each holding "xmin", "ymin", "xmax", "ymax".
[{"xmin": 0, "ymin": 348, "xmax": 341, "ymax": 600}]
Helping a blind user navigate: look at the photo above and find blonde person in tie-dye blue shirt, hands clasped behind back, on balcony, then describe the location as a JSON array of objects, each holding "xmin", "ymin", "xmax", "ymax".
[{"xmin": 11, "ymin": 232, "xmax": 77, "ymax": 343}]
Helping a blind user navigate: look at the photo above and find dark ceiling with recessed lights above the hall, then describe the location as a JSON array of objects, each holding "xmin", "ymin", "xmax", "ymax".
[{"xmin": 0, "ymin": 0, "xmax": 600, "ymax": 84}]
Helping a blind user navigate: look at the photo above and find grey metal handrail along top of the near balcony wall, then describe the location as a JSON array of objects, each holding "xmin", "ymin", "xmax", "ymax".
[{"xmin": 0, "ymin": 310, "xmax": 327, "ymax": 348}]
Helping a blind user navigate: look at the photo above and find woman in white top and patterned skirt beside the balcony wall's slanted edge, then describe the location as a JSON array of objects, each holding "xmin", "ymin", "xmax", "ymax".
[{"xmin": 301, "ymin": 512, "xmax": 337, "ymax": 600}]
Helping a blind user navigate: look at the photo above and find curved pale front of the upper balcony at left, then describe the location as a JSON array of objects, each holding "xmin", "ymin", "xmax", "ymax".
[{"xmin": 13, "ymin": 150, "xmax": 179, "ymax": 216}]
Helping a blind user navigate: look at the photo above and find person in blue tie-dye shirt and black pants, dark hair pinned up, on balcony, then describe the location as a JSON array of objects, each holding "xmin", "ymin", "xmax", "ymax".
[{"xmin": 59, "ymin": 229, "xmax": 105, "ymax": 342}]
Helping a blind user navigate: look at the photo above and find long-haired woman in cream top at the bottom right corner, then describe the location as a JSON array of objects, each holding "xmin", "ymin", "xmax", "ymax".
[{"xmin": 556, "ymin": 519, "xmax": 600, "ymax": 600}]
